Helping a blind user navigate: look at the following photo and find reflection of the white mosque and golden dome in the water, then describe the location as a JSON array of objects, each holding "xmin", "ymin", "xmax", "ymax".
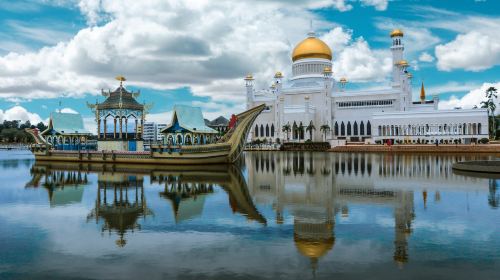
[{"xmin": 246, "ymin": 152, "xmax": 498, "ymax": 269}]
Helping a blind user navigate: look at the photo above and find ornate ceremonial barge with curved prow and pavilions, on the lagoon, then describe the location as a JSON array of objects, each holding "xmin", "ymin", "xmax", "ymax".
[{"xmin": 26, "ymin": 76, "xmax": 265, "ymax": 165}]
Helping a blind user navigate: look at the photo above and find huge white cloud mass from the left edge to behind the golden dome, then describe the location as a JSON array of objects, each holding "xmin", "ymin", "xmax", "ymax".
[{"xmin": 0, "ymin": 0, "xmax": 386, "ymax": 102}]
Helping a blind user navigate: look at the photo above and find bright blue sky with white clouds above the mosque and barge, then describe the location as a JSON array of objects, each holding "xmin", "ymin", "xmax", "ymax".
[{"xmin": 0, "ymin": 0, "xmax": 500, "ymax": 133}]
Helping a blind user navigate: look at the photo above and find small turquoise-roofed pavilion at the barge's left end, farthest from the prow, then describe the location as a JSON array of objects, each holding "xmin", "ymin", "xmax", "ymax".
[{"xmin": 41, "ymin": 112, "xmax": 91, "ymax": 150}]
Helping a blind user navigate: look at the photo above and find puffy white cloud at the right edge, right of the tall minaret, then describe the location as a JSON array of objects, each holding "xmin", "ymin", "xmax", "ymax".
[{"xmin": 435, "ymin": 30, "xmax": 500, "ymax": 71}]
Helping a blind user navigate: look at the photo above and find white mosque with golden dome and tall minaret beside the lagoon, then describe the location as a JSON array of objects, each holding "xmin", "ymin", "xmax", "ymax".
[{"xmin": 245, "ymin": 29, "xmax": 488, "ymax": 145}]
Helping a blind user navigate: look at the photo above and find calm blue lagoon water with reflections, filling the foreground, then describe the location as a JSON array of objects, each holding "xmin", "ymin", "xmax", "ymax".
[{"xmin": 0, "ymin": 151, "xmax": 500, "ymax": 280}]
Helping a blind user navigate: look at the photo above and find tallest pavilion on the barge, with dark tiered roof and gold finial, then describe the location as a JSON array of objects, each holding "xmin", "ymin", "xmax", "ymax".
[{"xmin": 88, "ymin": 76, "xmax": 151, "ymax": 151}]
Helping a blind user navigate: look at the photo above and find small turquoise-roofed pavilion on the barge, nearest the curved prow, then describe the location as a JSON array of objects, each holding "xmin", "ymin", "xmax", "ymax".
[{"xmin": 161, "ymin": 105, "xmax": 218, "ymax": 145}]
